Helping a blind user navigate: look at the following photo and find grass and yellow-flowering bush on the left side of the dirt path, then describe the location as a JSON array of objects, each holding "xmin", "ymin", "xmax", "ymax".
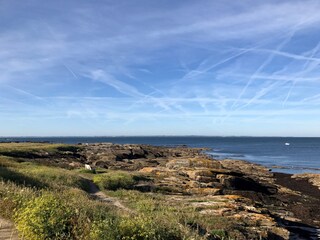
[{"xmin": 0, "ymin": 152, "xmax": 116, "ymax": 240}]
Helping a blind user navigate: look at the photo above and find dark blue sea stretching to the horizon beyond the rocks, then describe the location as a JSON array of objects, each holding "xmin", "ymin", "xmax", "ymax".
[{"xmin": 0, "ymin": 136, "xmax": 320, "ymax": 174}]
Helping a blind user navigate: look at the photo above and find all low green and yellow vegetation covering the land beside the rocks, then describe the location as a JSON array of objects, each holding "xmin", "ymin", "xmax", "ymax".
[{"xmin": 0, "ymin": 143, "xmax": 238, "ymax": 240}]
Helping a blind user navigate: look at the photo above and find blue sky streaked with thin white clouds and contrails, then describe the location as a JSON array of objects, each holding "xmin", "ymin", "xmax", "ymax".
[{"xmin": 0, "ymin": 0, "xmax": 320, "ymax": 137}]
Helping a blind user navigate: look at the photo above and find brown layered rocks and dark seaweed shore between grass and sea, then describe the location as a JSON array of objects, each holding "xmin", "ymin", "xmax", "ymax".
[{"xmin": 72, "ymin": 144, "xmax": 320, "ymax": 239}]
